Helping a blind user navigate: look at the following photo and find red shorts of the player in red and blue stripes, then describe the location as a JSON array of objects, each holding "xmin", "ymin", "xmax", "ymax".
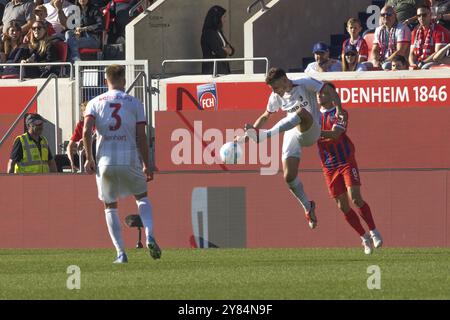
[{"xmin": 323, "ymin": 161, "xmax": 361, "ymax": 198}]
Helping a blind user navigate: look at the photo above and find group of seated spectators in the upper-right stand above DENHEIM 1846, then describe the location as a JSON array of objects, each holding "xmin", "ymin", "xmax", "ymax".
[{"xmin": 305, "ymin": 0, "xmax": 450, "ymax": 73}]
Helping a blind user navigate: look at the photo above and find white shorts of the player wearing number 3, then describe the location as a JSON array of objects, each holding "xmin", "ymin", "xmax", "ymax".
[{"xmin": 96, "ymin": 166, "xmax": 147, "ymax": 203}]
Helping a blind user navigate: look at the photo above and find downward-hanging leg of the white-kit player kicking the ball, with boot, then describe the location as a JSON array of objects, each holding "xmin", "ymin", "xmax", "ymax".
[{"xmin": 283, "ymin": 157, "xmax": 317, "ymax": 229}]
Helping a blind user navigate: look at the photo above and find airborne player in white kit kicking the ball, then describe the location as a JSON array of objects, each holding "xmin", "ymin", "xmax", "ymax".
[{"xmin": 236, "ymin": 68, "xmax": 343, "ymax": 229}]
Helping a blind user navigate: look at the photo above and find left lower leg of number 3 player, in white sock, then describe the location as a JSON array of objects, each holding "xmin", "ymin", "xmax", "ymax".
[{"xmin": 104, "ymin": 202, "xmax": 128, "ymax": 263}]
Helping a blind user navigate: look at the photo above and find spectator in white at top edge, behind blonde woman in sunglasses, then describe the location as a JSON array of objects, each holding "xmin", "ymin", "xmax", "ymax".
[{"xmin": 44, "ymin": 0, "xmax": 80, "ymax": 62}]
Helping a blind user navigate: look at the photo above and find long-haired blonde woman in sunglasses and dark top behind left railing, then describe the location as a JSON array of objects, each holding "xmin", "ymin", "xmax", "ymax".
[{"xmin": 21, "ymin": 21, "xmax": 59, "ymax": 78}]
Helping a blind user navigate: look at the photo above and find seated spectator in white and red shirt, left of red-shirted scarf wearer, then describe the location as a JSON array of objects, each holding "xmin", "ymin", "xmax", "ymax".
[{"xmin": 372, "ymin": 6, "xmax": 411, "ymax": 70}]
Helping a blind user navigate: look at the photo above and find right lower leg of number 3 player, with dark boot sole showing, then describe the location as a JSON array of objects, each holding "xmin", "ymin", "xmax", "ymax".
[{"xmin": 135, "ymin": 192, "xmax": 161, "ymax": 259}]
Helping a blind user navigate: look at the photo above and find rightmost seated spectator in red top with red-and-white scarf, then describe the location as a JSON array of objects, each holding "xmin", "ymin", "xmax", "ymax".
[{"xmin": 409, "ymin": 6, "xmax": 449, "ymax": 69}]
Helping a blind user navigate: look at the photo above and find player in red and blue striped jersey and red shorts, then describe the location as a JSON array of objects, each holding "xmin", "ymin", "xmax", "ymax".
[{"xmin": 317, "ymin": 84, "xmax": 382, "ymax": 254}]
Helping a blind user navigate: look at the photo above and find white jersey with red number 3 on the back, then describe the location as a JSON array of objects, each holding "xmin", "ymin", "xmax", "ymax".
[{"xmin": 85, "ymin": 90, "xmax": 146, "ymax": 167}]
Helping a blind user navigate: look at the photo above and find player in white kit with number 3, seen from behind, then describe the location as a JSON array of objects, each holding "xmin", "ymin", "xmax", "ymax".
[{"xmin": 83, "ymin": 65, "xmax": 161, "ymax": 263}]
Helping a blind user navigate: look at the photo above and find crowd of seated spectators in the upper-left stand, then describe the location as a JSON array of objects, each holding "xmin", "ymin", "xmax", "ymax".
[{"xmin": 0, "ymin": 0, "xmax": 148, "ymax": 77}]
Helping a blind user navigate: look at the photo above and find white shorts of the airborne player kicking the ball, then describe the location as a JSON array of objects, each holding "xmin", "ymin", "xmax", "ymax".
[{"xmin": 281, "ymin": 121, "xmax": 320, "ymax": 160}]
